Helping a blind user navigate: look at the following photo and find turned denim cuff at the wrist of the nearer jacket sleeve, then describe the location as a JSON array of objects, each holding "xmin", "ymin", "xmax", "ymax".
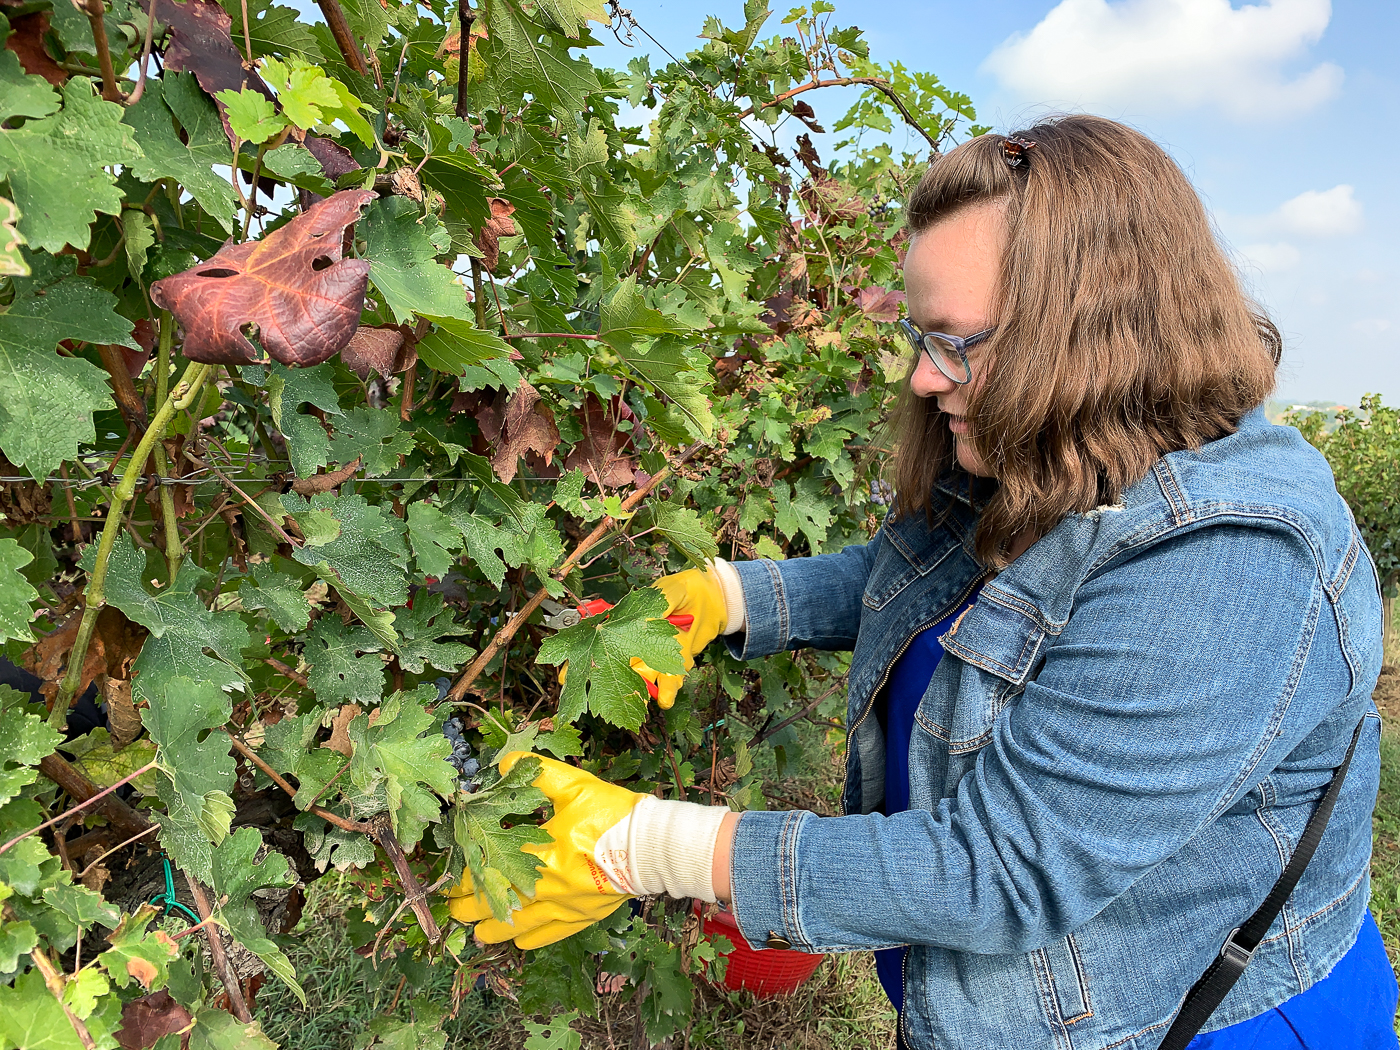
[{"xmin": 729, "ymin": 811, "xmax": 818, "ymax": 952}]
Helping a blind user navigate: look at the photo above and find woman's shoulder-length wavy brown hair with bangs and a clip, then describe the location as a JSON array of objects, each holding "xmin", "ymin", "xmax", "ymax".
[{"xmin": 895, "ymin": 116, "xmax": 1281, "ymax": 567}]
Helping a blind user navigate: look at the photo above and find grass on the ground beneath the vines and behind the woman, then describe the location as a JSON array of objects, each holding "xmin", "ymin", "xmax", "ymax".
[{"xmin": 258, "ymin": 669, "xmax": 1400, "ymax": 1050}]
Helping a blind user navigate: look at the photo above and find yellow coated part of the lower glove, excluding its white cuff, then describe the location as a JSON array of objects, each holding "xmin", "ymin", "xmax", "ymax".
[{"xmin": 448, "ymin": 750, "xmax": 648, "ymax": 948}]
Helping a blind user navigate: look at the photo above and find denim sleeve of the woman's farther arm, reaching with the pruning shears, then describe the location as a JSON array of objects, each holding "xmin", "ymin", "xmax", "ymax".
[{"xmin": 724, "ymin": 538, "xmax": 881, "ymax": 659}]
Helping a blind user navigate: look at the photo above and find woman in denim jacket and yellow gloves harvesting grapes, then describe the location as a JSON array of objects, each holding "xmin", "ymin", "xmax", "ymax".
[{"xmin": 454, "ymin": 116, "xmax": 1396, "ymax": 1050}]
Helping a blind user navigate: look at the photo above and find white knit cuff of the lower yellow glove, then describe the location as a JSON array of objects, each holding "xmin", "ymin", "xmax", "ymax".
[{"xmin": 594, "ymin": 795, "xmax": 729, "ymax": 903}]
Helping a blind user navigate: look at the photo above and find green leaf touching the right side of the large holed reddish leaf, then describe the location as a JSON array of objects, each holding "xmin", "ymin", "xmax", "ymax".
[{"xmin": 358, "ymin": 196, "xmax": 476, "ymax": 324}]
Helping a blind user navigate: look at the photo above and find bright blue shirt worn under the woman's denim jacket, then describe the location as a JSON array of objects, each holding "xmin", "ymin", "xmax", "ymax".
[{"xmin": 875, "ymin": 592, "xmax": 1397, "ymax": 1050}]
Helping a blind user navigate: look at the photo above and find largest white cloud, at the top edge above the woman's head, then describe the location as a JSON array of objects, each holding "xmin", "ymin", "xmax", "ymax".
[{"xmin": 983, "ymin": 0, "xmax": 1343, "ymax": 119}]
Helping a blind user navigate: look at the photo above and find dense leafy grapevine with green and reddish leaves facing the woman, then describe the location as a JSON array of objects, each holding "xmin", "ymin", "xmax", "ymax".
[{"xmin": 0, "ymin": 0, "xmax": 984, "ymax": 1050}]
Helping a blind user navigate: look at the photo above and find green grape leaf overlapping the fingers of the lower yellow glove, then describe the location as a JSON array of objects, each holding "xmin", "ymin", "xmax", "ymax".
[{"xmin": 452, "ymin": 756, "xmax": 553, "ymax": 921}]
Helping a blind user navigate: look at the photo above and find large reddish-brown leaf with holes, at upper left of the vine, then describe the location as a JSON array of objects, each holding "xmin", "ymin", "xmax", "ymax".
[{"xmin": 151, "ymin": 191, "xmax": 375, "ymax": 367}]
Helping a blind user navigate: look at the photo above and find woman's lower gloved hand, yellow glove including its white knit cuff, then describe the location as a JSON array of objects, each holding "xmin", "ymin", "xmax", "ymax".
[{"xmin": 448, "ymin": 752, "xmax": 729, "ymax": 948}]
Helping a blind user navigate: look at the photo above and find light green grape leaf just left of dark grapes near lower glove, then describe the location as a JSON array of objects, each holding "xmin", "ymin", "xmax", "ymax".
[{"xmin": 349, "ymin": 685, "xmax": 456, "ymax": 850}]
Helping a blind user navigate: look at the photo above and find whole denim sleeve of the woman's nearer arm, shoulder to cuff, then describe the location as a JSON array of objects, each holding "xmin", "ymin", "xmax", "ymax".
[{"xmin": 731, "ymin": 525, "xmax": 1369, "ymax": 953}]
